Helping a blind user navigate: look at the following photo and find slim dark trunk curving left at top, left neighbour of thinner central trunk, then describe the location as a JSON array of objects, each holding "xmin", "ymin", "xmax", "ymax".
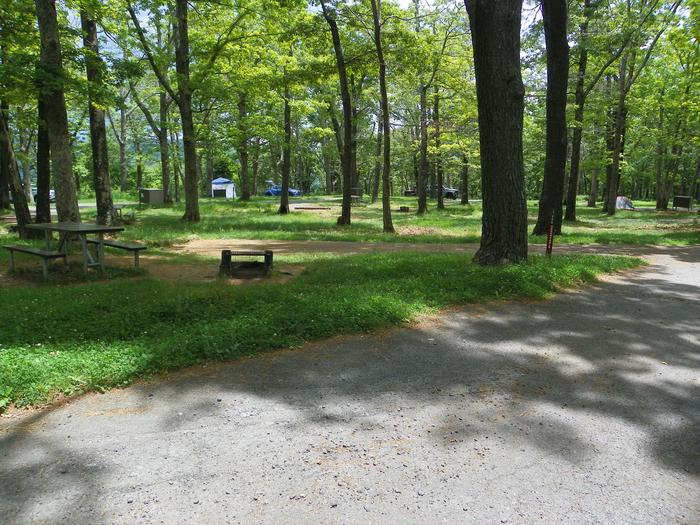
[{"xmin": 321, "ymin": 2, "xmax": 352, "ymax": 225}]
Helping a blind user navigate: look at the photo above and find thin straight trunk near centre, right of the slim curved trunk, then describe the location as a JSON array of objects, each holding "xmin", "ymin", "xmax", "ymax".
[{"xmin": 372, "ymin": 0, "xmax": 394, "ymax": 233}]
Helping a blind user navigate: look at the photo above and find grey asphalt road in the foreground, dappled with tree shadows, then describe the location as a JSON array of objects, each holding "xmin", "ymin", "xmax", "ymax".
[{"xmin": 0, "ymin": 247, "xmax": 700, "ymax": 525}]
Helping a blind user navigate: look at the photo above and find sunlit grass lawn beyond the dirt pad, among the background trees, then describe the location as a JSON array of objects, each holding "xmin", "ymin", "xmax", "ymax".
[{"xmin": 57, "ymin": 197, "xmax": 700, "ymax": 247}]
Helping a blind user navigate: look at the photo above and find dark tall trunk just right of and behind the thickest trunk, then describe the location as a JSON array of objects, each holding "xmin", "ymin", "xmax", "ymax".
[{"xmin": 532, "ymin": 0, "xmax": 576, "ymax": 235}]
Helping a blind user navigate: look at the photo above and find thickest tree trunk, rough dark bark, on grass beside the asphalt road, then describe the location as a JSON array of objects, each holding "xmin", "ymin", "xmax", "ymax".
[{"xmin": 466, "ymin": 0, "xmax": 527, "ymax": 264}]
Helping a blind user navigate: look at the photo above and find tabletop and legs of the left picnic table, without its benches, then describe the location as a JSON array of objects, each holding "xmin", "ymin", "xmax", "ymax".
[{"xmin": 26, "ymin": 222, "xmax": 124, "ymax": 272}]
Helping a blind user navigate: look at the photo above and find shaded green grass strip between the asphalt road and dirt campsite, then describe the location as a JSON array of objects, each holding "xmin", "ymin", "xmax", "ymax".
[{"xmin": 0, "ymin": 253, "xmax": 640, "ymax": 410}]
